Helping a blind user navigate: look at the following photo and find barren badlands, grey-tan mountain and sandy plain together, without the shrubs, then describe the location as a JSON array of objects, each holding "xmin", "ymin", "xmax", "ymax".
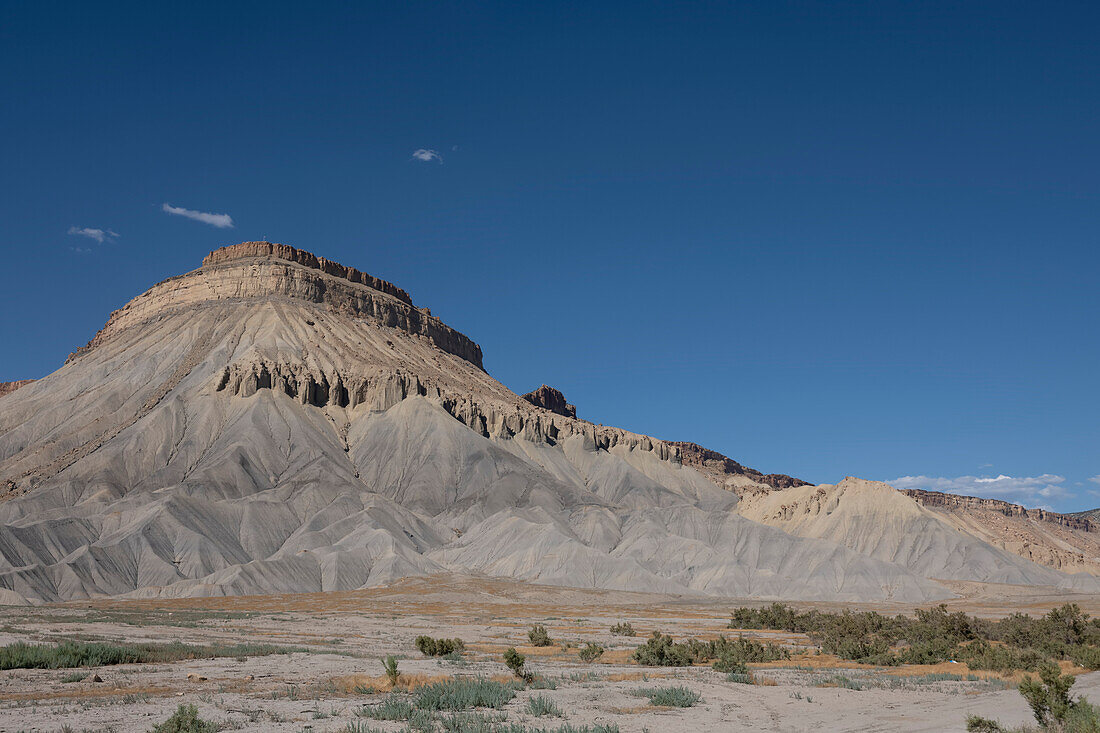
[{"xmin": 0, "ymin": 242, "xmax": 1100, "ymax": 732}]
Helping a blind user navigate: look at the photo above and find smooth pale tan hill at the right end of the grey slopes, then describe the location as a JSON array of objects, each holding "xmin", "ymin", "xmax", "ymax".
[{"xmin": 738, "ymin": 477, "xmax": 1098, "ymax": 590}]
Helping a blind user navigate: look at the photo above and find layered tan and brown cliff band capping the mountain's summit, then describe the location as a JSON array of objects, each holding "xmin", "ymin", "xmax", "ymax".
[{"xmin": 68, "ymin": 242, "xmax": 483, "ymax": 369}]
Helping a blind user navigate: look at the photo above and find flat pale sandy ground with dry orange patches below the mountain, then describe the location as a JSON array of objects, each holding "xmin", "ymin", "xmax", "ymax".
[{"xmin": 0, "ymin": 578, "xmax": 1100, "ymax": 733}]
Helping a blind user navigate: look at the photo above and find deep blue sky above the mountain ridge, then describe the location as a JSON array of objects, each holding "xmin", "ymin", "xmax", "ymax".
[{"xmin": 0, "ymin": 1, "xmax": 1100, "ymax": 510}]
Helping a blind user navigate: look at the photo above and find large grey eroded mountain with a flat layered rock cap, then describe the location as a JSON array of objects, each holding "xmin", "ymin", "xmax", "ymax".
[{"xmin": 0, "ymin": 242, "xmax": 1096, "ymax": 602}]
